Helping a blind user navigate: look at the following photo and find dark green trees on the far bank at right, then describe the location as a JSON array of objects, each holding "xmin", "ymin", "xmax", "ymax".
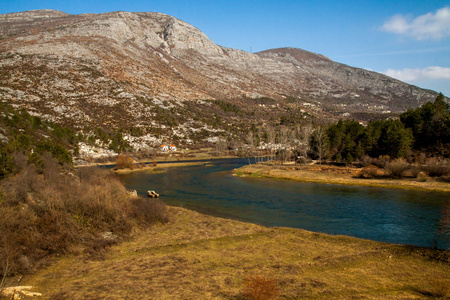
[{"xmin": 310, "ymin": 94, "xmax": 450, "ymax": 163}]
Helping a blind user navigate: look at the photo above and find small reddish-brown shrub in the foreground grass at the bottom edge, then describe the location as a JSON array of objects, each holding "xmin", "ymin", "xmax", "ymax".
[{"xmin": 244, "ymin": 275, "xmax": 280, "ymax": 300}]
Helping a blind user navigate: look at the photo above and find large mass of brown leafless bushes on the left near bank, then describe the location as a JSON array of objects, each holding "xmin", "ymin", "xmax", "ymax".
[{"xmin": 0, "ymin": 156, "xmax": 167, "ymax": 279}]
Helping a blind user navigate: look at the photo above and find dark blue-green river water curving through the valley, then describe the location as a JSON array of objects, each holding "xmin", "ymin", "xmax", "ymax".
[{"xmin": 120, "ymin": 159, "xmax": 450, "ymax": 248}]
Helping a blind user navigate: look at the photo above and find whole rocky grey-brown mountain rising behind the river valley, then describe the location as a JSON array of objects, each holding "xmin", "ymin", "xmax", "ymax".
[{"xmin": 0, "ymin": 10, "xmax": 437, "ymax": 151}]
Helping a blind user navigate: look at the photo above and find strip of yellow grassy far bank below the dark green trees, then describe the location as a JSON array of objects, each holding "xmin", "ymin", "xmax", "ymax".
[{"xmin": 234, "ymin": 164, "xmax": 450, "ymax": 193}]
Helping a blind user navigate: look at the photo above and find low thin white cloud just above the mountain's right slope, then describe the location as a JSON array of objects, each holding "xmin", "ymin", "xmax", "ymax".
[{"xmin": 384, "ymin": 66, "xmax": 450, "ymax": 82}]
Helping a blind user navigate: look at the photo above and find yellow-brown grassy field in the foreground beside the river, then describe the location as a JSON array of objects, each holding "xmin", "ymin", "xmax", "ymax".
[{"xmin": 8, "ymin": 207, "xmax": 450, "ymax": 299}]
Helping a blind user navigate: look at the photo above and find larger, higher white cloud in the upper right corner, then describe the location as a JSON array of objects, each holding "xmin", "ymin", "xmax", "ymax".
[{"xmin": 381, "ymin": 7, "xmax": 450, "ymax": 40}]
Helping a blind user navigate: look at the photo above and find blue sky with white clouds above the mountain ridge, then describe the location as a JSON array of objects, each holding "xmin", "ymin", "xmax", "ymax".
[{"xmin": 0, "ymin": 0, "xmax": 450, "ymax": 97}]
